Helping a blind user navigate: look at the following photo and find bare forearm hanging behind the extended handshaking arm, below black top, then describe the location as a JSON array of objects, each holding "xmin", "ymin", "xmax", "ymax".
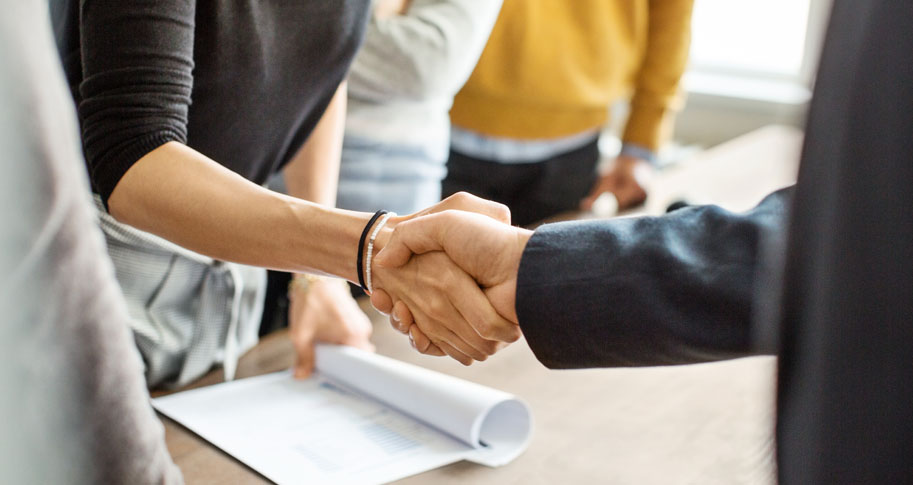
[{"xmin": 283, "ymin": 81, "xmax": 346, "ymax": 207}]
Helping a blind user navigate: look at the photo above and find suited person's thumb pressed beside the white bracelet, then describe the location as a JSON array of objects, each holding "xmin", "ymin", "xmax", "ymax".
[{"xmin": 374, "ymin": 211, "xmax": 447, "ymax": 268}]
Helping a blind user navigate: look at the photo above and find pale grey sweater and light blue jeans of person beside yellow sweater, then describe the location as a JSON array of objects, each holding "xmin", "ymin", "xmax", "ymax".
[{"xmin": 338, "ymin": 0, "xmax": 501, "ymax": 213}]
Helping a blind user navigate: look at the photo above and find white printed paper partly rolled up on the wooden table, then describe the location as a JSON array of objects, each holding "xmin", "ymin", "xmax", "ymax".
[{"xmin": 152, "ymin": 345, "xmax": 532, "ymax": 485}]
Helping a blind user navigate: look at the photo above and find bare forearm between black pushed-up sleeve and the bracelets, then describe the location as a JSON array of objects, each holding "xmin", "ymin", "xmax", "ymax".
[{"xmin": 109, "ymin": 142, "xmax": 370, "ymax": 281}]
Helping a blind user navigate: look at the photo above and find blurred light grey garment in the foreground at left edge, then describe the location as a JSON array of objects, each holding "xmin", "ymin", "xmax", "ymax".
[{"xmin": 0, "ymin": 0, "xmax": 182, "ymax": 484}]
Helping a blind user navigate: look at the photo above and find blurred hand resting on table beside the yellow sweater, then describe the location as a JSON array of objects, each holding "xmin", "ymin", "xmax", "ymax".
[{"xmin": 580, "ymin": 155, "xmax": 653, "ymax": 211}]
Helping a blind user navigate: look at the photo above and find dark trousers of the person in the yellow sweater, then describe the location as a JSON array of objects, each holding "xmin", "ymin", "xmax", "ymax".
[{"xmin": 441, "ymin": 137, "xmax": 599, "ymax": 226}]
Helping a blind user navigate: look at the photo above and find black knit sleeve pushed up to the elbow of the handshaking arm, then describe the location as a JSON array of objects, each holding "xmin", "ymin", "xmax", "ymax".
[{"xmin": 79, "ymin": 0, "xmax": 196, "ymax": 204}]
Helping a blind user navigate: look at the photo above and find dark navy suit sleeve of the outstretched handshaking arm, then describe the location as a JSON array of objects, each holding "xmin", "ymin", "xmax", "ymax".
[{"xmin": 516, "ymin": 188, "xmax": 792, "ymax": 368}]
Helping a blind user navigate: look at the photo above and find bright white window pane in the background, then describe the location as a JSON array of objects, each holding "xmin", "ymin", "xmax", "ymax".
[{"xmin": 691, "ymin": 0, "xmax": 810, "ymax": 78}]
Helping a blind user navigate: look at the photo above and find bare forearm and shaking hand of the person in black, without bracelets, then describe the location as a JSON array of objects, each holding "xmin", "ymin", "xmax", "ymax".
[{"xmin": 110, "ymin": 149, "xmax": 515, "ymax": 364}]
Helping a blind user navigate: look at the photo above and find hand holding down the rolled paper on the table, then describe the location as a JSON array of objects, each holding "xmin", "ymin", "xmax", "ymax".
[{"xmin": 289, "ymin": 278, "xmax": 374, "ymax": 379}]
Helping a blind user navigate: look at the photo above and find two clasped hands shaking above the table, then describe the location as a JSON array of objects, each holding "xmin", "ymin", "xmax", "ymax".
[{"xmin": 371, "ymin": 193, "xmax": 532, "ymax": 365}]
